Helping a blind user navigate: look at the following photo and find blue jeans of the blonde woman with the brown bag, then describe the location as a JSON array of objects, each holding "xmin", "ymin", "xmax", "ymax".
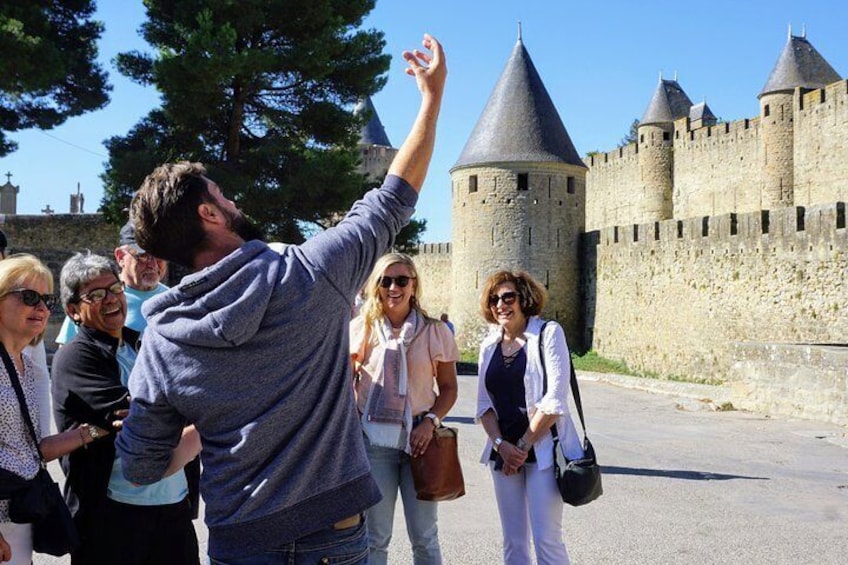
[{"xmin": 365, "ymin": 437, "xmax": 442, "ymax": 565}]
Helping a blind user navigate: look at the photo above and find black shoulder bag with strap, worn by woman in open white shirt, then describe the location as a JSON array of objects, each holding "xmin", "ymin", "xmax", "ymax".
[{"xmin": 539, "ymin": 322, "xmax": 604, "ymax": 506}]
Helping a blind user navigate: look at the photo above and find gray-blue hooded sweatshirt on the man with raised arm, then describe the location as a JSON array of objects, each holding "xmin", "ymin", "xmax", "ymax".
[{"xmin": 116, "ymin": 176, "xmax": 417, "ymax": 559}]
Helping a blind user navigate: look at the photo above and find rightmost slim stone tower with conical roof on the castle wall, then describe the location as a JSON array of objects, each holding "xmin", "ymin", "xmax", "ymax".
[{"xmin": 758, "ymin": 29, "xmax": 840, "ymax": 210}]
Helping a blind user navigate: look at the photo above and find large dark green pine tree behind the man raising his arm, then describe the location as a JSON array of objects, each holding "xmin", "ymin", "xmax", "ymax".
[{"xmin": 103, "ymin": 0, "xmax": 390, "ymax": 236}]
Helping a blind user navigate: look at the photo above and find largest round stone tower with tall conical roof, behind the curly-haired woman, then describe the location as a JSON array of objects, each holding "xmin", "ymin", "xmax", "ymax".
[{"xmin": 450, "ymin": 30, "xmax": 586, "ymax": 348}]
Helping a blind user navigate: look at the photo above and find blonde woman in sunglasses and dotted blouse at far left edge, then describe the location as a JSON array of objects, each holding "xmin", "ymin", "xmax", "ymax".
[{"xmin": 0, "ymin": 255, "xmax": 108, "ymax": 565}]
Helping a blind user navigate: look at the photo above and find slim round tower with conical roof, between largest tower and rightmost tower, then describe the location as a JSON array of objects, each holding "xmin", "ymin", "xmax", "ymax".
[{"xmin": 633, "ymin": 76, "xmax": 692, "ymax": 223}]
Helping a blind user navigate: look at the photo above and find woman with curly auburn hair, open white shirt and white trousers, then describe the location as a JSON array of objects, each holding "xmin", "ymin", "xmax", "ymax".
[{"xmin": 477, "ymin": 271, "xmax": 583, "ymax": 565}]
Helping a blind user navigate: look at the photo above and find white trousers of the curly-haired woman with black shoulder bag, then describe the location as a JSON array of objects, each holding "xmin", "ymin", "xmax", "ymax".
[{"xmin": 489, "ymin": 463, "xmax": 570, "ymax": 565}]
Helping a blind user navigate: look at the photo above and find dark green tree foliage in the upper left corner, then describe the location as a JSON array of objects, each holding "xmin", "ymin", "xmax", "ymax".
[{"xmin": 0, "ymin": 0, "xmax": 111, "ymax": 156}]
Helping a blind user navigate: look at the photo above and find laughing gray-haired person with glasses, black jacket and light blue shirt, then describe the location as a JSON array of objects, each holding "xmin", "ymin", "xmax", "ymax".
[{"xmin": 53, "ymin": 252, "xmax": 200, "ymax": 565}]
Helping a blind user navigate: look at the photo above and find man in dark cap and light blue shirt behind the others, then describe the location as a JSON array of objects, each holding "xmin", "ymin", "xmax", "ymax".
[{"xmin": 56, "ymin": 222, "xmax": 168, "ymax": 345}]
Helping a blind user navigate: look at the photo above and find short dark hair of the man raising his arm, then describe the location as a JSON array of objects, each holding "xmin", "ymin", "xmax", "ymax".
[{"xmin": 130, "ymin": 161, "xmax": 213, "ymax": 269}]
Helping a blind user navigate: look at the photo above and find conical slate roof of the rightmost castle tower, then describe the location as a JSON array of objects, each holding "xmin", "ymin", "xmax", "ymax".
[{"xmin": 758, "ymin": 33, "xmax": 841, "ymax": 98}]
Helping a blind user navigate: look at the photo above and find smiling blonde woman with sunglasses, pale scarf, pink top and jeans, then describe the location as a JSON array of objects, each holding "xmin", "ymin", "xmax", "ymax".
[{"xmin": 350, "ymin": 253, "xmax": 459, "ymax": 565}]
